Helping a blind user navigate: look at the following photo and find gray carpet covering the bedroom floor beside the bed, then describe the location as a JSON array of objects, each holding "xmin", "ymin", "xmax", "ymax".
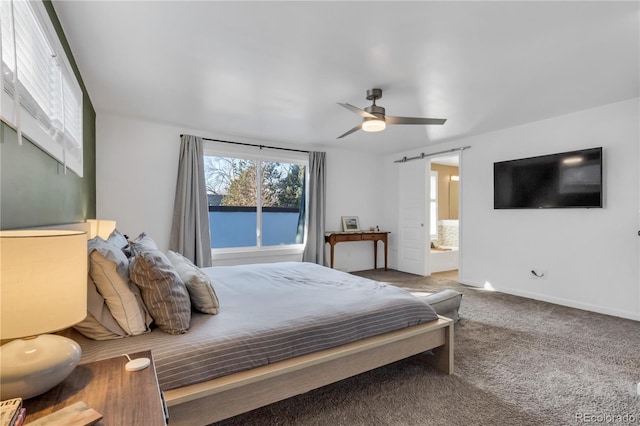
[{"xmin": 212, "ymin": 270, "xmax": 640, "ymax": 426}]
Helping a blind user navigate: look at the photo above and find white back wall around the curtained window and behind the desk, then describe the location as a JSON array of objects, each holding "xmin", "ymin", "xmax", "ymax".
[{"xmin": 96, "ymin": 114, "xmax": 384, "ymax": 271}]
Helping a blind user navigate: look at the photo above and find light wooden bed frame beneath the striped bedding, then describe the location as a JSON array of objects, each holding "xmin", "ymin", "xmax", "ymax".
[{"xmin": 41, "ymin": 223, "xmax": 454, "ymax": 426}]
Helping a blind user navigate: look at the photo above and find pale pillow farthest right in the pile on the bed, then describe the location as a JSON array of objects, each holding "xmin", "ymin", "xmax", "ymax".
[{"xmin": 167, "ymin": 250, "xmax": 220, "ymax": 315}]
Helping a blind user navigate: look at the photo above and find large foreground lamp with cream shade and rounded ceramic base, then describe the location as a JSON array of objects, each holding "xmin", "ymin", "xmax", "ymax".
[{"xmin": 0, "ymin": 230, "xmax": 87, "ymax": 400}]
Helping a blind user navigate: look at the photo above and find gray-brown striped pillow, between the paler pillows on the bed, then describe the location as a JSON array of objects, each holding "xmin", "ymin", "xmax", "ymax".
[{"xmin": 129, "ymin": 236, "xmax": 191, "ymax": 334}]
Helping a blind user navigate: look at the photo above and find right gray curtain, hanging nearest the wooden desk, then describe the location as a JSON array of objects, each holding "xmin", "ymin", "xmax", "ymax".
[{"xmin": 302, "ymin": 152, "xmax": 326, "ymax": 265}]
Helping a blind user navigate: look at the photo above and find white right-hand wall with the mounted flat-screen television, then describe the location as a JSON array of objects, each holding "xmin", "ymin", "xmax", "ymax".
[{"xmin": 385, "ymin": 98, "xmax": 640, "ymax": 320}]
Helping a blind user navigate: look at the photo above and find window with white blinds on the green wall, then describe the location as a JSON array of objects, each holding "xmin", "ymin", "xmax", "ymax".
[{"xmin": 0, "ymin": 0, "xmax": 83, "ymax": 176}]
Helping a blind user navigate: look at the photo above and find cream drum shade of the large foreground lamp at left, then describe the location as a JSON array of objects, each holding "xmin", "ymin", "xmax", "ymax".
[{"xmin": 0, "ymin": 230, "xmax": 87, "ymax": 340}]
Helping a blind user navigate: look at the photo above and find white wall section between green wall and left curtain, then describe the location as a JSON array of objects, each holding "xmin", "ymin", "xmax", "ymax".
[{"xmin": 96, "ymin": 114, "xmax": 183, "ymax": 250}]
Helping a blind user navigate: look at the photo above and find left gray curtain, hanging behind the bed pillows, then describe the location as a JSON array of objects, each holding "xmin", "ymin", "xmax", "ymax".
[{"xmin": 169, "ymin": 135, "xmax": 211, "ymax": 268}]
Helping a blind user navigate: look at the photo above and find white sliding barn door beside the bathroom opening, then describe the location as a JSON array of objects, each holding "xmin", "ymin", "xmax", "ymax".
[{"xmin": 398, "ymin": 161, "xmax": 430, "ymax": 276}]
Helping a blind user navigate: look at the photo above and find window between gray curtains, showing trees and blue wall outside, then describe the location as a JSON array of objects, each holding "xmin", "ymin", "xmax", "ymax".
[{"xmin": 204, "ymin": 148, "xmax": 308, "ymax": 249}]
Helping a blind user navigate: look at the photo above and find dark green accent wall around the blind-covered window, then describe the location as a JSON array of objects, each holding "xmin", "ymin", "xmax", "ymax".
[{"xmin": 0, "ymin": 1, "xmax": 96, "ymax": 229}]
